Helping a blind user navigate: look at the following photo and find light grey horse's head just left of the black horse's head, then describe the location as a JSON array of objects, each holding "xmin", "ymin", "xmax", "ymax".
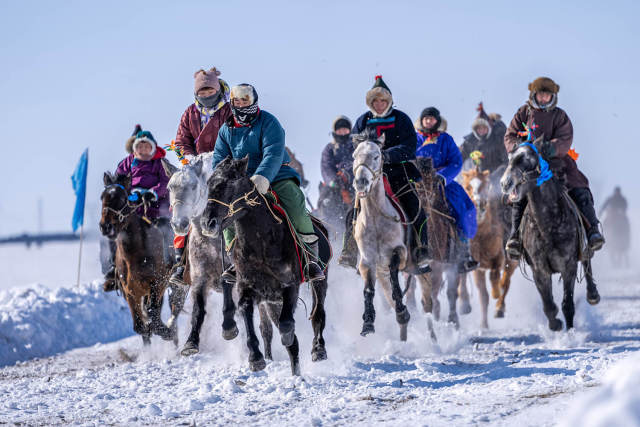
[{"xmin": 163, "ymin": 153, "xmax": 213, "ymax": 236}]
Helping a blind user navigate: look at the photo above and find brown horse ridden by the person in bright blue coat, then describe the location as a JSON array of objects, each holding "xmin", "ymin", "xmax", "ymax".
[{"xmin": 416, "ymin": 158, "xmax": 471, "ymax": 328}]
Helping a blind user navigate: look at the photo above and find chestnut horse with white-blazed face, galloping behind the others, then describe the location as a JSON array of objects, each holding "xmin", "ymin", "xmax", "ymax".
[{"xmin": 461, "ymin": 167, "xmax": 518, "ymax": 328}]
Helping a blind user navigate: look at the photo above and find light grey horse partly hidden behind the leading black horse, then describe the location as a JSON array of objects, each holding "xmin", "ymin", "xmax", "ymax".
[{"xmin": 165, "ymin": 152, "xmax": 273, "ymax": 360}]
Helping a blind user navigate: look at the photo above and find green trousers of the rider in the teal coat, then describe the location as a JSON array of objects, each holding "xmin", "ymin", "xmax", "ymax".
[{"xmin": 223, "ymin": 179, "xmax": 314, "ymax": 250}]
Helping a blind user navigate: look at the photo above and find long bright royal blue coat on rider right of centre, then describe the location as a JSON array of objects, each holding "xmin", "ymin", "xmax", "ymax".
[{"xmin": 416, "ymin": 132, "xmax": 478, "ymax": 239}]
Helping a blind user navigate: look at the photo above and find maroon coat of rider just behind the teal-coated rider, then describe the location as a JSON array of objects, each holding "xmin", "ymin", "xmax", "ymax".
[{"xmin": 175, "ymin": 103, "xmax": 231, "ymax": 155}]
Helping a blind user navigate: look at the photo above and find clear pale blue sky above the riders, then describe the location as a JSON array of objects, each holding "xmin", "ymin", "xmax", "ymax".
[{"xmin": 0, "ymin": 0, "xmax": 640, "ymax": 235}]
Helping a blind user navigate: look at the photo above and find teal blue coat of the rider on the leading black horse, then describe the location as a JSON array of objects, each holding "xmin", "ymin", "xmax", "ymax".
[{"xmin": 213, "ymin": 110, "xmax": 300, "ymax": 184}]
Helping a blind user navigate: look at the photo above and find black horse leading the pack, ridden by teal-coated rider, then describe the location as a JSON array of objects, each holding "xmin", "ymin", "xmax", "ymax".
[{"xmin": 201, "ymin": 157, "xmax": 330, "ymax": 375}]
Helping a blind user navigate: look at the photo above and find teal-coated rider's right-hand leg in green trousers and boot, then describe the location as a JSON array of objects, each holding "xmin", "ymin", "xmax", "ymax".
[{"xmin": 271, "ymin": 179, "xmax": 325, "ymax": 282}]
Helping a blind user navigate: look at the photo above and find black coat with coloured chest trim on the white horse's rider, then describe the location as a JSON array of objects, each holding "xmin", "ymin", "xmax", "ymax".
[{"xmin": 352, "ymin": 108, "xmax": 422, "ymax": 186}]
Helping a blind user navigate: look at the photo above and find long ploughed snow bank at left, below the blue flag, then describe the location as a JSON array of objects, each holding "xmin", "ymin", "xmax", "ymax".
[{"xmin": 0, "ymin": 281, "xmax": 133, "ymax": 366}]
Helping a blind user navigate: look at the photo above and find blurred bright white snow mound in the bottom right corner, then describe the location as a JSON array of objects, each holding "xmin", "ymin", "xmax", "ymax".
[{"xmin": 560, "ymin": 353, "xmax": 640, "ymax": 427}]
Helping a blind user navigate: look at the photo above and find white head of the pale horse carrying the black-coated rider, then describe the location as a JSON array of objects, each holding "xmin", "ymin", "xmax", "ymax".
[{"xmin": 353, "ymin": 134, "xmax": 385, "ymax": 198}]
